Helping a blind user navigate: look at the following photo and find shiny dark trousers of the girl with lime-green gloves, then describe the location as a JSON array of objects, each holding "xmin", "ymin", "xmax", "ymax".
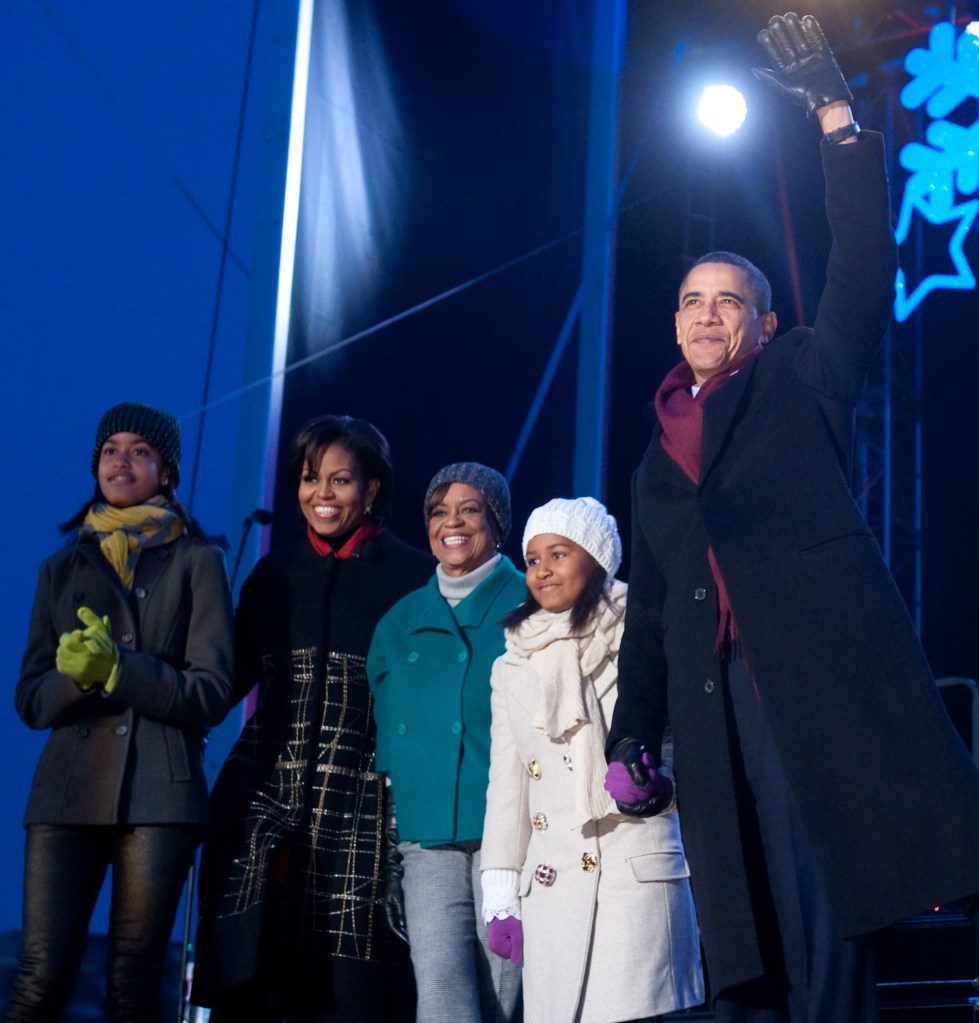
[{"xmin": 5, "ymin": 825, "xmax": 201, "ymax": 1023}]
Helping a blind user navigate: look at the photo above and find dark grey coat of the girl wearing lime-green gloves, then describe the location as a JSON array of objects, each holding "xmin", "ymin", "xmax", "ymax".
[{"xmin": 15, "ymin": 535, "xmax": 235, "ymax": 826}]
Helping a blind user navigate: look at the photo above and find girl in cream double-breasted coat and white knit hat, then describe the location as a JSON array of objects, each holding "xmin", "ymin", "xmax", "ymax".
[{"xmin": 482, "ymin": 497, "xmax": 704, "ymax": 1023}]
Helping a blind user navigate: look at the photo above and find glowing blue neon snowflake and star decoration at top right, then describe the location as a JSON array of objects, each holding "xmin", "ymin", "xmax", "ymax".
[{"xmin": 894, "ymin": 21, "xmax": 979, "ymax": 321}]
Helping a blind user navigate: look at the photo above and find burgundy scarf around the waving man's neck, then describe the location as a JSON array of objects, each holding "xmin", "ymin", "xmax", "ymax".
[{"xmin": 655, "ymin": 345, "xmax": 761, "ymax": 651}]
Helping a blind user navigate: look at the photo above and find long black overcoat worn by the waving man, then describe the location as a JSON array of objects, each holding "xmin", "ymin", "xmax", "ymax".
[{"xmin": 609, "ymin": 132, "xmax": 979, "ymax": 992}]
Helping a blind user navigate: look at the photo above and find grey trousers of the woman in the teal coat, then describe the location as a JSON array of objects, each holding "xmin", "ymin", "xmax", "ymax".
[{"xmin": 398, "ymin": 842, "xmax": 521, "ymax": 1023}]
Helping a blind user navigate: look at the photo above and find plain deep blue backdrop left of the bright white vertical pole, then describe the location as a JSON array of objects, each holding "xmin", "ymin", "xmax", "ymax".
[{"xmin": 0, "ymin": 0, "xmax": 272, "ymax": 930}]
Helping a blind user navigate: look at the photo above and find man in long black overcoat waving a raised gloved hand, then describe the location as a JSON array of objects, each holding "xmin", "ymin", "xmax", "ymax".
[{"xmin": 607, "ymin": 14, "xmax": 979, "ymax": 1023}]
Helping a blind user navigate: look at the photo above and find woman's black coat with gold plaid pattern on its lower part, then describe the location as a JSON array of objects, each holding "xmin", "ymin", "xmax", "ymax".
[{"xmin": 193, "ymin": 532, "xmax": 433, "ymax": 1006}]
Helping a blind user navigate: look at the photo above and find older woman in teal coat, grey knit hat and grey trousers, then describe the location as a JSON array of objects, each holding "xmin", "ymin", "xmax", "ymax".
[{"xmin": 367, "ymin": 462, "xmax": 527, "ymax": 1023}]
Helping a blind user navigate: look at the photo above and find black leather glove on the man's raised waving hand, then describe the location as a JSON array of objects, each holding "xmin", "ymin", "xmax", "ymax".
[{"xmin": 752, "ymin": 12, "xmax": 853, "ymax": 114}]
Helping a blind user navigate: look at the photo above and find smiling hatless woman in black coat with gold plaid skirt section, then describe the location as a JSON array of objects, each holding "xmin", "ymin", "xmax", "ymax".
[{"xmin": 193, "ymin": 416, "xmax": 432, "ymax": 1023}]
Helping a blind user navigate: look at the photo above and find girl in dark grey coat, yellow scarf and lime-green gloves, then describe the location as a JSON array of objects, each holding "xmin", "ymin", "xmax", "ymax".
[{"xmin": 6, "ymin": 403, "xmax": 234, "ymax": 1023}]
